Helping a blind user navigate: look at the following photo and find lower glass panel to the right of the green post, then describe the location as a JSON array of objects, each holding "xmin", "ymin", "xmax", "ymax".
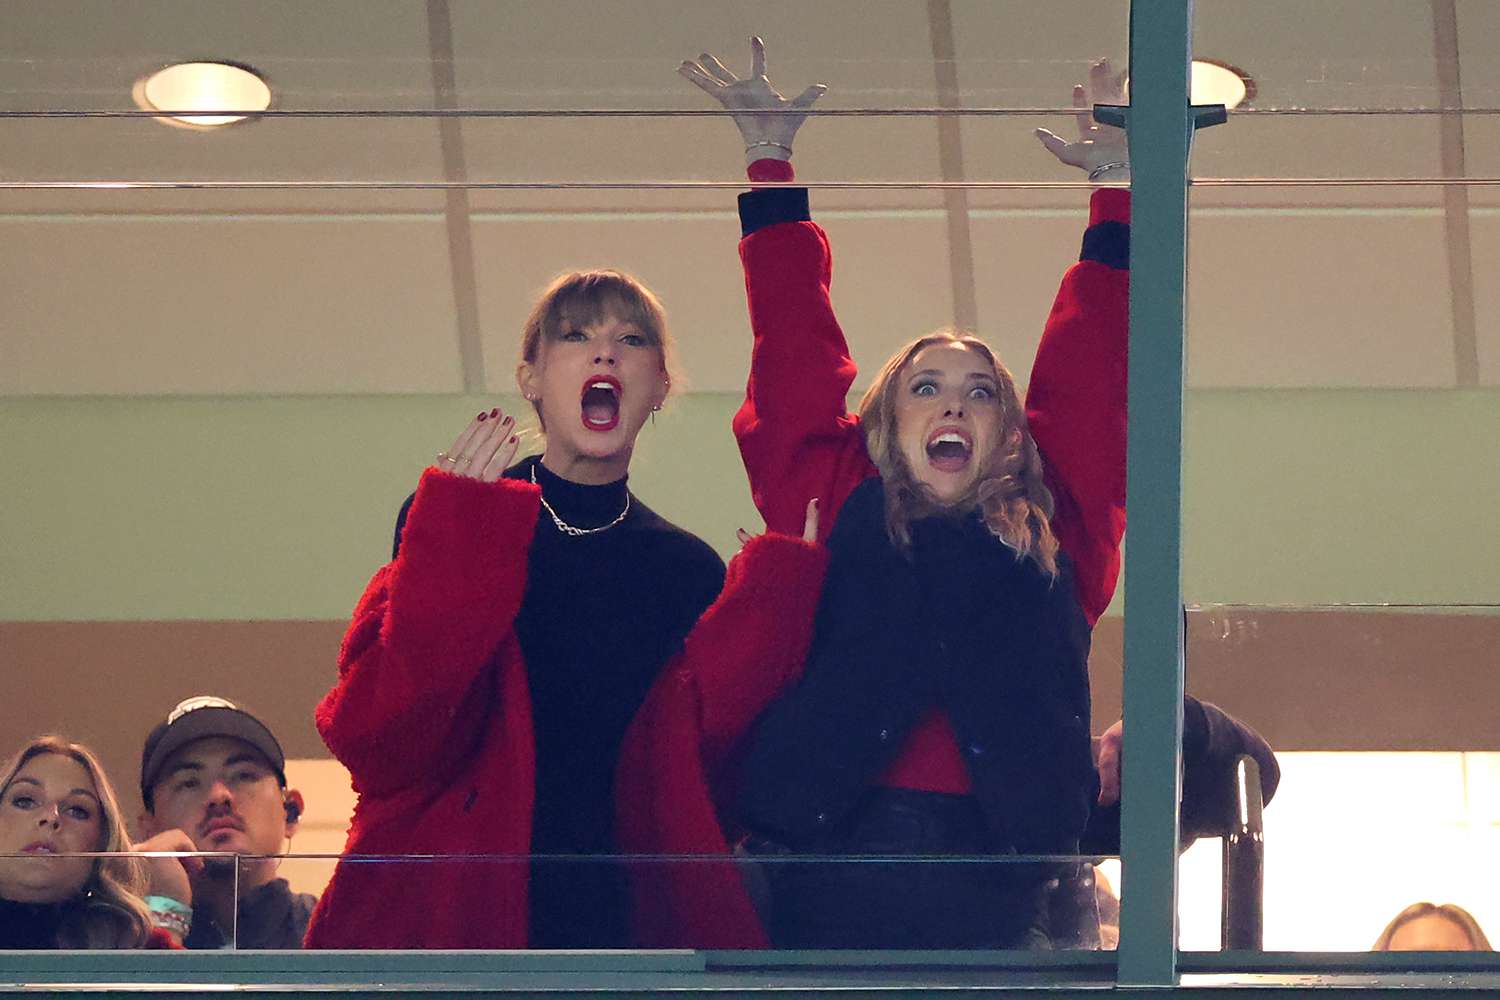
[{"xmin": 1182, "ymin": 606, "xmax": 1500, "ymax": 952}]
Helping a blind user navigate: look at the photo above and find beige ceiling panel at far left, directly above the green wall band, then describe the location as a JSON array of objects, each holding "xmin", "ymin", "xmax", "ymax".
[{"xmin": 0, "ymin": 217, "xmax": 462, "ymax": 394}]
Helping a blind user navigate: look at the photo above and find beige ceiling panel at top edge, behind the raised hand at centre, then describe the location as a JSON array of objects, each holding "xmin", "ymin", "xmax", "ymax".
[{"xmin": 452, "ymin": 0, "xmax": 933, "ymax": 110}]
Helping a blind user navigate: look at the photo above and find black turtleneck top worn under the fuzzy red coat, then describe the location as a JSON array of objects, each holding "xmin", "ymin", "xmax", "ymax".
[{"xmin": 396, "ymin": 457, "xmax": 725, "ymax": 948}]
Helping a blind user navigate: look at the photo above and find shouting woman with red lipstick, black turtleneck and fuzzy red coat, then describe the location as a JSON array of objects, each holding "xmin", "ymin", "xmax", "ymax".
[{"xmin": 308, "ymin": 271, "xmax": 725, "ymax": 948}]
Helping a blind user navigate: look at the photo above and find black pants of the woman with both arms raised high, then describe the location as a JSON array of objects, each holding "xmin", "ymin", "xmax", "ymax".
[{"xmin": 752, "ymin": 789, "xmax": 1053, "ymax": 949}]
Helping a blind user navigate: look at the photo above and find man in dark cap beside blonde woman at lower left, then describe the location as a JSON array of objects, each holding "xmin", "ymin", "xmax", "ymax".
[{"xmin": 137, "ymin": 697, "xmax": 318, "ymax": 949}]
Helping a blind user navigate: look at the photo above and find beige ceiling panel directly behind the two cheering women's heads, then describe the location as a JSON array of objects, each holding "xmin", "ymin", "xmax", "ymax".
[{"xmin": 474, "ymin": 194, "xmax": 951, "ymax": 393}]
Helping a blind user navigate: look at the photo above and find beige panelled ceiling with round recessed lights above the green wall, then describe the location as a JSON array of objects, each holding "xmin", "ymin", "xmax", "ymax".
[{"xmin": 0, "ymin": 0, "xmax": 1500, "ymax": 396}]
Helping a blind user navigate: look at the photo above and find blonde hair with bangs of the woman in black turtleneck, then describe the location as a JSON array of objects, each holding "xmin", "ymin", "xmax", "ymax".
[{"xmin": 521, "ymin": 267, "xmax": 680, "ymax": 430}]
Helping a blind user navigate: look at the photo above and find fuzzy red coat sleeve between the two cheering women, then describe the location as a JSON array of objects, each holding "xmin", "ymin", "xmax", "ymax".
[{"xmin": 678, "ymin": 534, "xmax": 828, "ymax": 772}]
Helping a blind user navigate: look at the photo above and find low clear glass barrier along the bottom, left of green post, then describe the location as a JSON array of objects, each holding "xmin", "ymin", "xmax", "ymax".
[{"xmin": 0, "ymin": 851, "xmax": 1118, "ymax": 952}]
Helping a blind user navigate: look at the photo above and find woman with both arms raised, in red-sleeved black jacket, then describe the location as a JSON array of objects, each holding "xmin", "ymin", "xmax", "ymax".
[{"xmin": 683, "ymin": 39, "xmax": 1130, "ymax": 948}]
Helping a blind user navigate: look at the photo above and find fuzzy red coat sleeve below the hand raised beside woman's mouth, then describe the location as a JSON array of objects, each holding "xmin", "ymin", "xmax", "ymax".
[{"xmin": 315, "ymin": 469, "xmax": 540, "ymax": 795}]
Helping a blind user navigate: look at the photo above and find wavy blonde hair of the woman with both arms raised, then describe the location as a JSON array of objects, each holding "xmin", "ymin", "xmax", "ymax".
[{"xmin": 860, "ymin": 330, "xmax": 1058, "ymax": 577}]
